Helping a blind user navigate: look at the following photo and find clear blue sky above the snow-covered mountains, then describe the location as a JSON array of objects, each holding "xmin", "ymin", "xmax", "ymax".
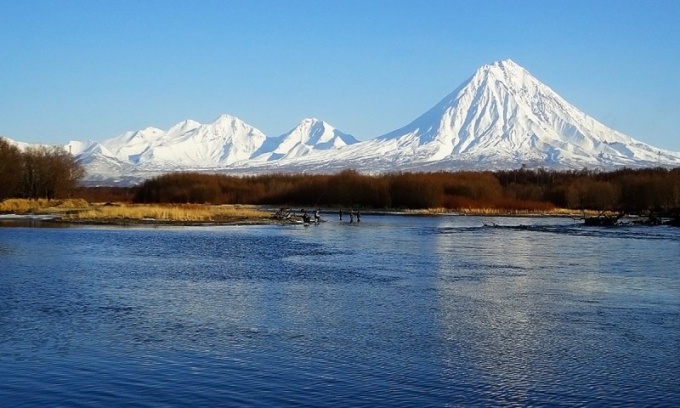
[{"xmin": 0, "ymin": 0, "xmax": 680, "ymax": 151}]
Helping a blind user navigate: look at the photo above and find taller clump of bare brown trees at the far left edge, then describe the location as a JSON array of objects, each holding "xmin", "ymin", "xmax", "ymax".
[{"xmin": 0, "ymin": 137, "xmax": 85, "ymax": 200}]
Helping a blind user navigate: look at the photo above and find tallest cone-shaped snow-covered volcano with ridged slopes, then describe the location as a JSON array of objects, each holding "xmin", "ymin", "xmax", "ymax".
[{"xmin": 366, "ymin": 60, "xmax": 680, "ymax": 168}]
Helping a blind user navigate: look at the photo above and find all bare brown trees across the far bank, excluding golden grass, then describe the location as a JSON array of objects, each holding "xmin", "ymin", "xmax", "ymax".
[{"xmin": 0, "ymin": 142, "xmax": 680, "ymax": 214}]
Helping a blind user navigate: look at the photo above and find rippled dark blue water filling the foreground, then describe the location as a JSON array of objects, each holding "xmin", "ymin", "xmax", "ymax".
[{"xmin": 0, "ymin": 216, "xmax": 680, "ymax": 407}]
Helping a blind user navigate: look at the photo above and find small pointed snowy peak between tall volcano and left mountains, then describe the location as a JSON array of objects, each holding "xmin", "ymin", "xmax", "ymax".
[{"xmin": 253, "ymin": 118, "xmax": 359, "ymax": 161}]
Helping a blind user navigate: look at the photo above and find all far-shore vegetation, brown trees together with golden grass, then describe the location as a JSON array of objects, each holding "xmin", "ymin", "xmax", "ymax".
[{"xmin": 0, "ymin": 138, "xmax": 680, "ymax": 223}]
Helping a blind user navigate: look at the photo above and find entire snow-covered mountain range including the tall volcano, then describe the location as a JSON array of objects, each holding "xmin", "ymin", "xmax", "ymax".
[{"xmin": 5, "ymin": 60, "xmax": 680, "ymax": 183}]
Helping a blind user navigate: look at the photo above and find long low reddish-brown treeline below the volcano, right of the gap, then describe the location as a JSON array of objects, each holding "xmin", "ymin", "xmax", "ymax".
[{"xmin": 133, "ymin": 168, "xmax": 680, "ymax": 212}]
